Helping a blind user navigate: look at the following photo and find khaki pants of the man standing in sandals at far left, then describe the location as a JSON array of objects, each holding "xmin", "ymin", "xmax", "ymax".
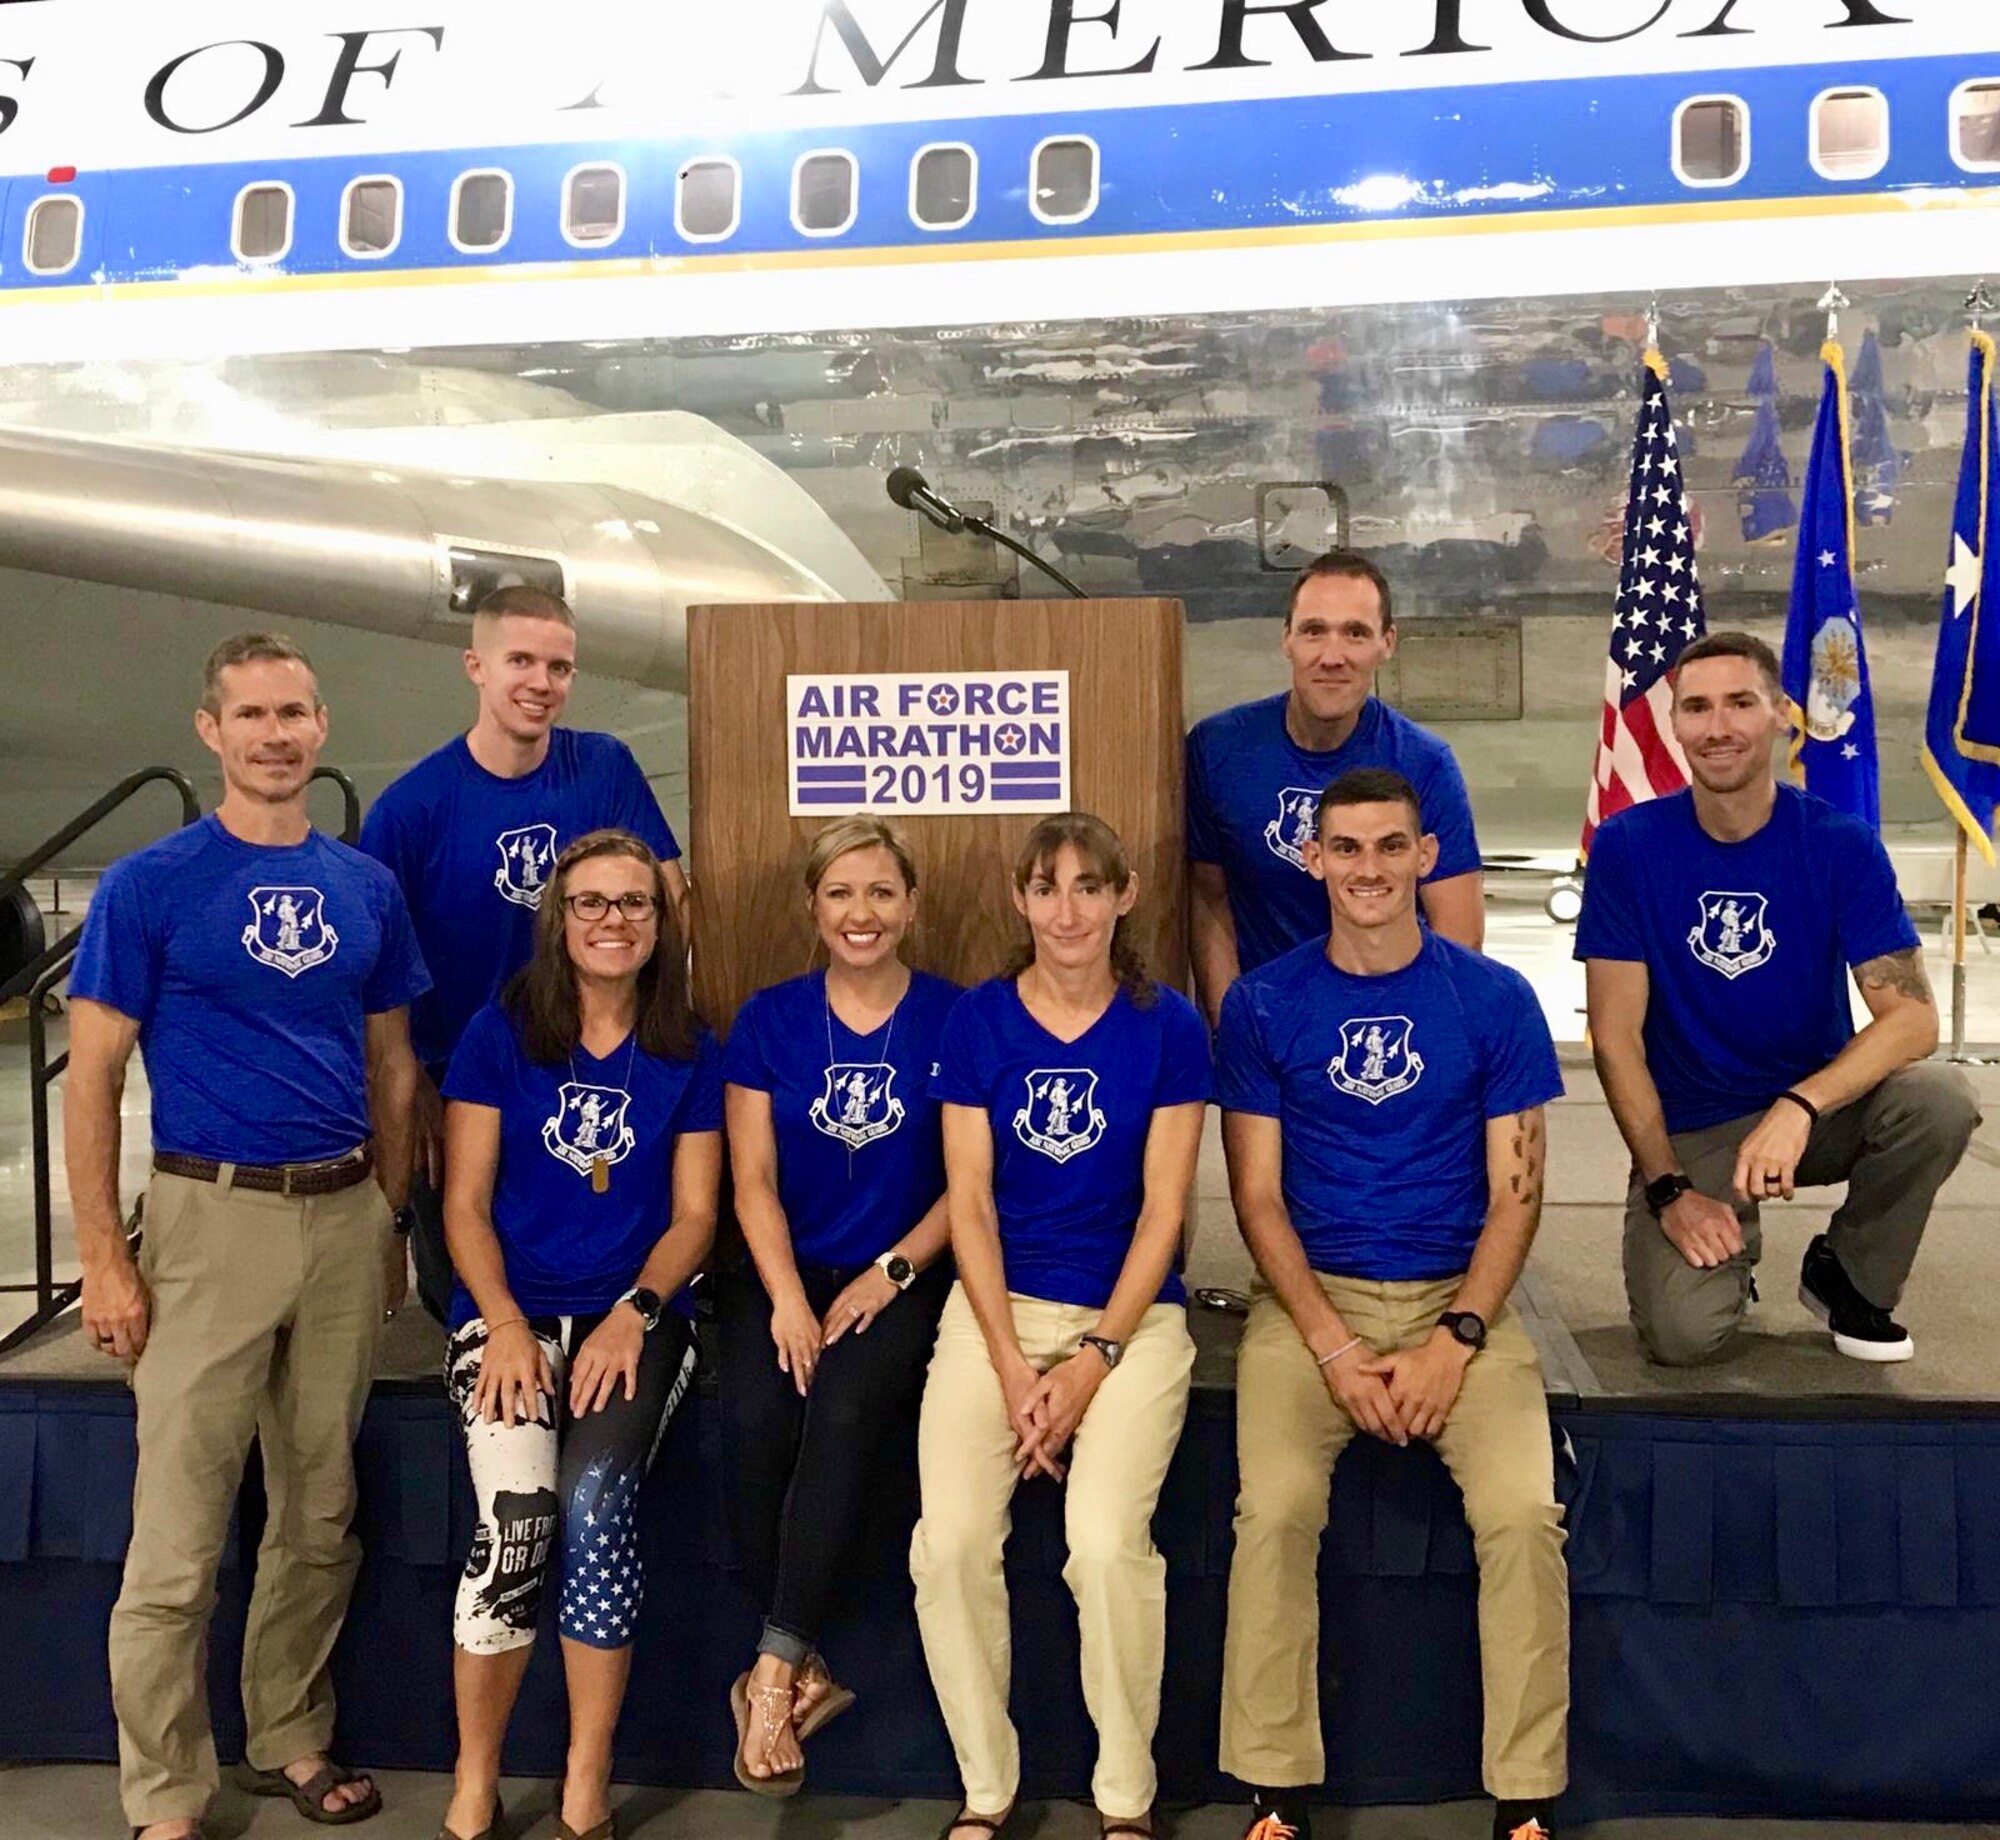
[{"xmin": 110, "ymin": 1166, "xmax": 390, "ymax": 1826}]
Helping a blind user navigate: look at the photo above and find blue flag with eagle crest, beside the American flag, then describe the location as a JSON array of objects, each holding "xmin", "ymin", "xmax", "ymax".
[{"xmin": 1784, "ymin": 344, "xmax": 1882, "ymax": 830}]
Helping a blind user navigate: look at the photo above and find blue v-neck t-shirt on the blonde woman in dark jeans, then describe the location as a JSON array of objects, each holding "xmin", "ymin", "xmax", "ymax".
[{"xmin": 722, "ymin": 972, "xmax": 962, "ymax": 1266}]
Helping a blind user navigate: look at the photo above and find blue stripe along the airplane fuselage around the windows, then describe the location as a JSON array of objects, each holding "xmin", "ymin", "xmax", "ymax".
[{"xmin": 0, "ymin": 50, "xmax": 2000, "ymax": 290}]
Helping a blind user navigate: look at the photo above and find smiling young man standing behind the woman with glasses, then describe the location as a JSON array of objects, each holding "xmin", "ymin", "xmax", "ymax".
[{"xmin": 362, "ymin": 586, "xmax": 688, "ymax": 1320}]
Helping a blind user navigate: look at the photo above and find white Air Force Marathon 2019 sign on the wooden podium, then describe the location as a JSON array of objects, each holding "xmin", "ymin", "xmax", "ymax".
[{"xmin": 784, "ymin": 670, "xmax": 1070, "ymax": 818}]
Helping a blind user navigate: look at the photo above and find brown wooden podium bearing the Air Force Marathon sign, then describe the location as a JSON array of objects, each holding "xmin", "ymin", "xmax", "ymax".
[{"xmin": 688, "ymin": 600, "xmax": 1188, "ymax": 1028}]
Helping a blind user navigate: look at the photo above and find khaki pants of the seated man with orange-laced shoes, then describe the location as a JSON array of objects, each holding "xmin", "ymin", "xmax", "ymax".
[{"xmin": 1222, "ymin": 1274, "xmax": 1570, "ymax": 1800}]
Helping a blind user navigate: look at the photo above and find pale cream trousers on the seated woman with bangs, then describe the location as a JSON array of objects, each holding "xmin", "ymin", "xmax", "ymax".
[{"xmin": 910, "ymin": 1284, "xmax": 1194, "ymax": 1818}]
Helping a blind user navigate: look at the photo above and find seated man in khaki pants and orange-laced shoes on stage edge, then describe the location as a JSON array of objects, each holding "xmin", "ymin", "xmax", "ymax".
[{"xmin": 1216, "ymin": 768, "xmax": 1570, "ymax": 1840}]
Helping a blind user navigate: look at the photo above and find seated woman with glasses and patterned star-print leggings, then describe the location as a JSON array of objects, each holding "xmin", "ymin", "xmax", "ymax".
[{"xmin": 440, "ymin": 830, "xmax": 722, "ymax": 1840}]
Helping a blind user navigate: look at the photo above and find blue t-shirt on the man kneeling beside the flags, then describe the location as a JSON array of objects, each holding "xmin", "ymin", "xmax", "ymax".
[{"xmin": 1576, "ymin": 786, "xmax": 1918, "ymax": 1132}]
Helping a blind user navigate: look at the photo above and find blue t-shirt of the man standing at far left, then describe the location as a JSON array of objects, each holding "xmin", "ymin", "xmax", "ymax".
[{"xmin": 70, "ymin": 814, "xmax": 430, "ymax": 1164}]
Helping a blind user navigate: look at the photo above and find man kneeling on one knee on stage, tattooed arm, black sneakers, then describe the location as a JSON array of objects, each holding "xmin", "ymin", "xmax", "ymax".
[{"xmin": 1576, "ymin": 632, "xmax": 1978, "ymax": 1366}]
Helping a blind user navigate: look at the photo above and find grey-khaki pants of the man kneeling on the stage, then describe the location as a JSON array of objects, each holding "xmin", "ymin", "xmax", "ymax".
[{"xmin": 1624, "ymin": 1060, "xmax": 1980, "ymax": 1366}]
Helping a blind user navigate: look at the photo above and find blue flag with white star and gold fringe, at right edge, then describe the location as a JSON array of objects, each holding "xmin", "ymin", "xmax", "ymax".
[{"xmin": 1924, "ymin": 332, "xmax": 2000, "ymax": 862}]
